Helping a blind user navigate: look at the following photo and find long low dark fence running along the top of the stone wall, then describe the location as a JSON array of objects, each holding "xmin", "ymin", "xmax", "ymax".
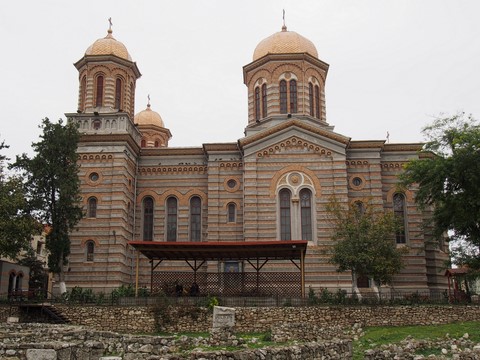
[{"xmin": 0, "ymin": 286, "xmax": 474, "ymax": 307}]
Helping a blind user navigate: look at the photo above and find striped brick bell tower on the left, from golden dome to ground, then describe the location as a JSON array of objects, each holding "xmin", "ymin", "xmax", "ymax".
[{"xmin": 66, "ymin": 20, "xmax": 142, "ymax": 292}]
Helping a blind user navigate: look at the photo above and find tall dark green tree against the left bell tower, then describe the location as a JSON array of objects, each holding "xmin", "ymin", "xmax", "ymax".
[{"xmin": 13, "ymin": 118, "xmax": 83, "ymax": 293}]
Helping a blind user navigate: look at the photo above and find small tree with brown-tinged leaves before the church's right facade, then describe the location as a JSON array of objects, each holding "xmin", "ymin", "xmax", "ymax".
[{"xmin": 327, "ymin": 199, "xmax": 408, "ymax": 298}]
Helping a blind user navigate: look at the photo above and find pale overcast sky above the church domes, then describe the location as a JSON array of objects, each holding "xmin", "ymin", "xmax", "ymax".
[{"xmin": 0, "ymin": 0, "xmax": 480, "ymax": 157}]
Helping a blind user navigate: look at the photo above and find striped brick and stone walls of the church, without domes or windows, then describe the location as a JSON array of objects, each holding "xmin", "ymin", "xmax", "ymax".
[{"xmin": 62, "ymin": 25, "xmax": 448, "ymax": 291}]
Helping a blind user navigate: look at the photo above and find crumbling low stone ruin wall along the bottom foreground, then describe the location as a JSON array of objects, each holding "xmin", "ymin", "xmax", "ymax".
[{"xmin": 0, "ymin": 323, "xmax": 352, "ymax": 360}]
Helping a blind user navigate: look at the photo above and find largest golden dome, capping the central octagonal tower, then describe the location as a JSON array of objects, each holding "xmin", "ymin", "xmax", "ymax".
[{"xmin": 253, "ymin": 25, "xmax": 318, "ymax": 61}]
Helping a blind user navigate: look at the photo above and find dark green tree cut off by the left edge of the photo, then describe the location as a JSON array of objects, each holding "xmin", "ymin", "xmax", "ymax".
[{"xmin": 0, "ymin": 142, "xmax": 40, "ymax": 260}]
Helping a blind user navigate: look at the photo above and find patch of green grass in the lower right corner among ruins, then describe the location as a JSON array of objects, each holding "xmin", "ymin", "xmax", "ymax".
[{"xmin": 353, "ymin": 321, "xmax": 480, "ymax": 359}]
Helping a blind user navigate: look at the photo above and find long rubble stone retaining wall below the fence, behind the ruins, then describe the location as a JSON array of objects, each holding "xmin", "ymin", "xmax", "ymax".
[{"xmin": 46, "ymin": 305, "xmax": 480, "ymax": 333}]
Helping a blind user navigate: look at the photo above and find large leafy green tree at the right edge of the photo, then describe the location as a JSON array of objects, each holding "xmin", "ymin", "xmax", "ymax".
[{"xmin": 402, "ymin": 113, "xmax": 480, "ymax": 269}]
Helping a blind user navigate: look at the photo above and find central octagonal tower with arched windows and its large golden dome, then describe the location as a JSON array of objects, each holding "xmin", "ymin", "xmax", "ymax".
[{"xmin": 243, "ymin": 24, "xmax": 329, "ymax": 133}]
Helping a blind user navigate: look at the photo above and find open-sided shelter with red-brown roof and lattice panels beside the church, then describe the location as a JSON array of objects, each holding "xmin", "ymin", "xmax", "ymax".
[{"xmin": 129, "ymin": 240, "xmax": 308, "ymax": 297}]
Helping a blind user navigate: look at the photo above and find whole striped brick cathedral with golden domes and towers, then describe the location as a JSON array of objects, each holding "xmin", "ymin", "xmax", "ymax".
[{"xmin": 66, "ymin": 21, "xmax": 448, "ymax": 296}]
